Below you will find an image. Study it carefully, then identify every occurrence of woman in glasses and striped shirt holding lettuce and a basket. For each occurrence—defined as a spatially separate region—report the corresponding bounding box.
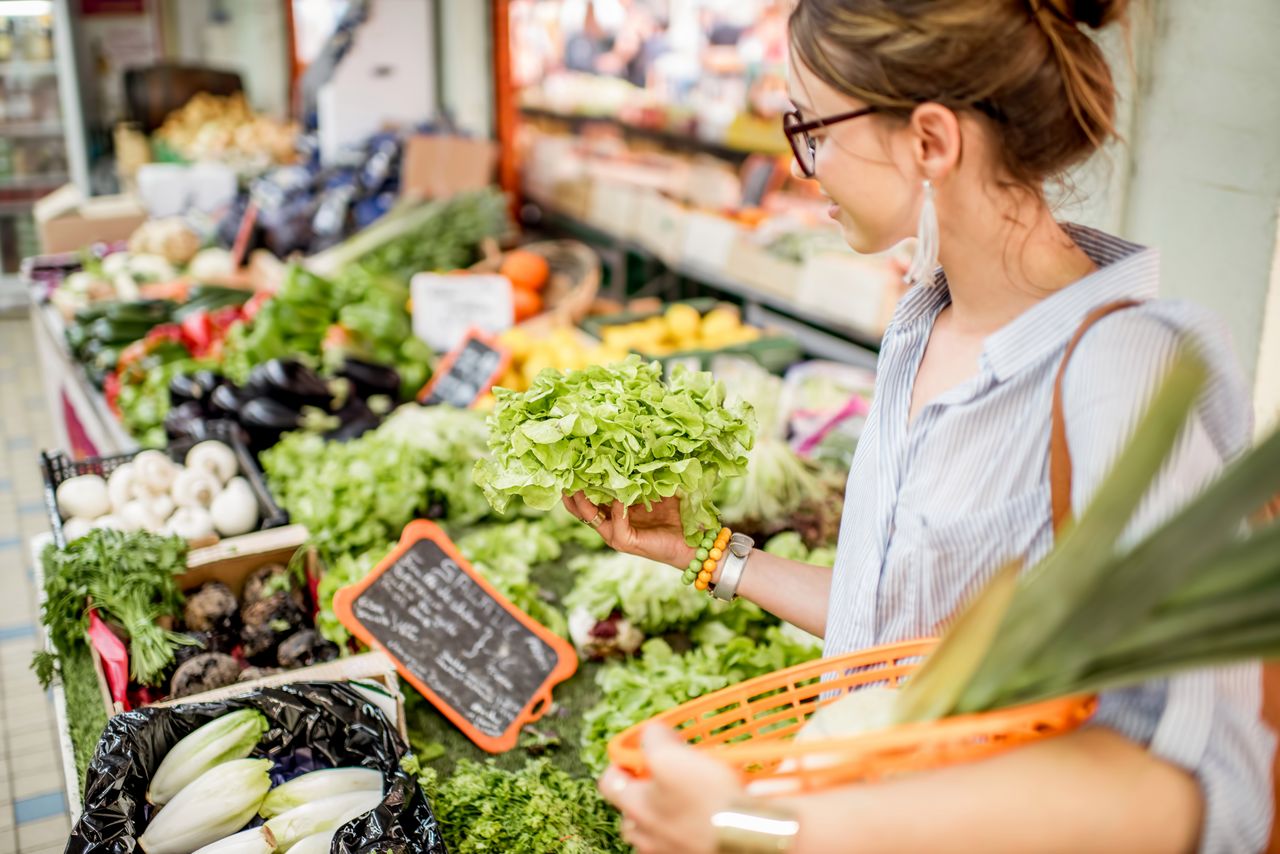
[566,0,1274,854]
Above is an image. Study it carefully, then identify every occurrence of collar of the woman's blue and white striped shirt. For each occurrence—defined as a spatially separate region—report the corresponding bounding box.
[884,223,1160,382]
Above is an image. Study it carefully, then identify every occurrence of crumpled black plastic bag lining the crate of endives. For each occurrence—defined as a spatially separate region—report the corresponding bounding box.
[67,682,447,854]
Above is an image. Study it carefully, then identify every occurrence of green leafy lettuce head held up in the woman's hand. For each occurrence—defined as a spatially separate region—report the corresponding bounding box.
[476,357,754,536]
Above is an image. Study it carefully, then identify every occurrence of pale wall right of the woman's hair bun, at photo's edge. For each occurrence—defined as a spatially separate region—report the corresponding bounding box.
[1121,0,1280,393]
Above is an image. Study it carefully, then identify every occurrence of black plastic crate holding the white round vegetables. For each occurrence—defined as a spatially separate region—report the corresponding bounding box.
[40,421,289,548]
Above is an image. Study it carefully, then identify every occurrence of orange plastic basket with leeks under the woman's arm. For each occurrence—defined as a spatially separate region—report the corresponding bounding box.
[609,640,1097,795]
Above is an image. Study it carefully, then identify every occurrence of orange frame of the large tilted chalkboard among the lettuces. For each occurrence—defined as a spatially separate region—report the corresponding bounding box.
[333,520,577,753]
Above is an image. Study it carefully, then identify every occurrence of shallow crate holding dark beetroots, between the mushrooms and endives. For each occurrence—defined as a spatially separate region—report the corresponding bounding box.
[90,525,404,736]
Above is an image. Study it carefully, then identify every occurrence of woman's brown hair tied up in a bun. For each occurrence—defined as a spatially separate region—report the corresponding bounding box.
[791,0,1128,187]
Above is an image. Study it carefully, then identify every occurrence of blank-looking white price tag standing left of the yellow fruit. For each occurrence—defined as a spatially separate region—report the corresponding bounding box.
[410,273,515,352]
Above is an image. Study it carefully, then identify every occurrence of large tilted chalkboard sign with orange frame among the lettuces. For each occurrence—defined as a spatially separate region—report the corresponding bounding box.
[333,521,577,753]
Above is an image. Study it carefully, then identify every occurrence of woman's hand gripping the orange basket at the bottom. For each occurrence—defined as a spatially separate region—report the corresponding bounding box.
[600,726,742,854]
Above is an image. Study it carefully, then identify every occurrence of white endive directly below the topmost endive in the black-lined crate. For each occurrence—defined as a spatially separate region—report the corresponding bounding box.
[138,759,274,854]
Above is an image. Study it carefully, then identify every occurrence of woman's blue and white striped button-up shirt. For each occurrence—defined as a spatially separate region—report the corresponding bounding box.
[826,225,1275,851]
